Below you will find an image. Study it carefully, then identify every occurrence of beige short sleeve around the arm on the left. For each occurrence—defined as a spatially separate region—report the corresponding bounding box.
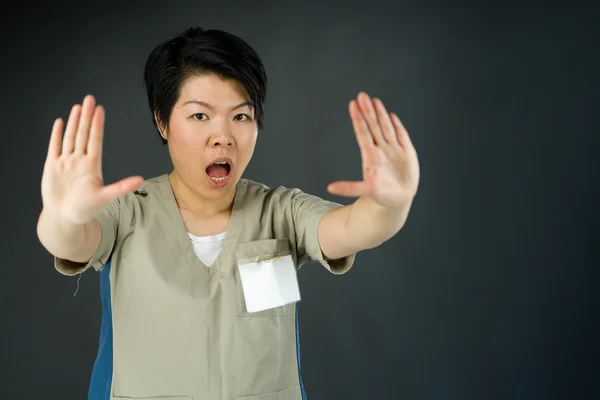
[54,199,120,276]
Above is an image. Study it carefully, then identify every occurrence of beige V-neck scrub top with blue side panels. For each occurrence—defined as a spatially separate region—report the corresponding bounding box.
[54,174,355,400]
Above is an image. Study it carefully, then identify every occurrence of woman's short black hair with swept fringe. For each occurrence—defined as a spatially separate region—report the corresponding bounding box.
[144,27,267,144]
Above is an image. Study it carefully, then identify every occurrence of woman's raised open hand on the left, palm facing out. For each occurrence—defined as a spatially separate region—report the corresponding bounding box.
[42,95,144,225]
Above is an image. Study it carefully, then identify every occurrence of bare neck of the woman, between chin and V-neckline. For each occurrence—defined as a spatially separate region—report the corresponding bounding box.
[169,170,235,218]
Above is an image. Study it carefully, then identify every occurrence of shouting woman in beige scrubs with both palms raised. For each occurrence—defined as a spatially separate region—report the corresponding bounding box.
[37,28,419,400]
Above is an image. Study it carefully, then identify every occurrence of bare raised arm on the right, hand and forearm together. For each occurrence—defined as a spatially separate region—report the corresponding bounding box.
[318,93,419,259]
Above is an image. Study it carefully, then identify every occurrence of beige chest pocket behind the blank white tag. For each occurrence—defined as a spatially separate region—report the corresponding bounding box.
[235,239,297,318]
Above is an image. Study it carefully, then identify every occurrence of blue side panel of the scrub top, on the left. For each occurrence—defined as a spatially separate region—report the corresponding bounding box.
[88,260,113,400]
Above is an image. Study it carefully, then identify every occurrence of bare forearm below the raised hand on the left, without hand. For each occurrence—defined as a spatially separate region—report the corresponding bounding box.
[37,210,102,262]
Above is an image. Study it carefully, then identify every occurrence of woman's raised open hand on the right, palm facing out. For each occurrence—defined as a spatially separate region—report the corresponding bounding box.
[327,93,420,208]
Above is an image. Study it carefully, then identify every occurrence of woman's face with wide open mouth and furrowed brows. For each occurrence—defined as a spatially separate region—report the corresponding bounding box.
[162,74,258,200]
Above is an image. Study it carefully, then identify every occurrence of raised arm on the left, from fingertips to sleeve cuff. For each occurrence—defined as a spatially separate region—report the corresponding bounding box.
[37,96,143,275]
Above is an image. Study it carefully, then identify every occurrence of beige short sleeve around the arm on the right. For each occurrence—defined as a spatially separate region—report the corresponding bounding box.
[291,189,356,275]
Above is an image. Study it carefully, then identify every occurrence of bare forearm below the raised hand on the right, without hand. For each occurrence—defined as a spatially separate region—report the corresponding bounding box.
[319,197,412,259]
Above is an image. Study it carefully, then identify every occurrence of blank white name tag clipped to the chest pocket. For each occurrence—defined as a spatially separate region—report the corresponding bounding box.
[238,255,300,313]
